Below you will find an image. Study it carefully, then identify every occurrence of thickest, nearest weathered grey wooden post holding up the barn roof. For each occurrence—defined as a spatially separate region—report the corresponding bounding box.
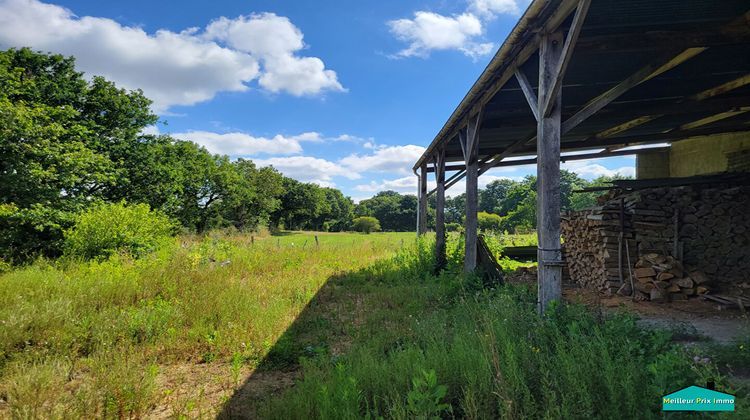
[537,32,563,313]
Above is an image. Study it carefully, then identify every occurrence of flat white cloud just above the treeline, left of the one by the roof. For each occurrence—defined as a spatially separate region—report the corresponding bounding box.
[253,156,361,186]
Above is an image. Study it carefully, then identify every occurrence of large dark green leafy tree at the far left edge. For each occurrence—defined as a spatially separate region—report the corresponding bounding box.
[0,49,156,260]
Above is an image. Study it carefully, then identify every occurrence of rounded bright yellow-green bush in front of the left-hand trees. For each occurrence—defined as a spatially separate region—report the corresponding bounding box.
[65,202,176,259]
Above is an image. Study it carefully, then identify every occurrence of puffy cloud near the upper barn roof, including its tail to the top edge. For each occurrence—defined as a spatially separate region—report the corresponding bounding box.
[387,0,529,59]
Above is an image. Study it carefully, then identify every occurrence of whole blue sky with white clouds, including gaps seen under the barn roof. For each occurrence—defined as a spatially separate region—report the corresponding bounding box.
[0,0,634,200]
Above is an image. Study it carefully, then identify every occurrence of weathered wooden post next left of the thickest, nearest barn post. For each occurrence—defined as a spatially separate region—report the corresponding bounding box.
[459,112,482,273]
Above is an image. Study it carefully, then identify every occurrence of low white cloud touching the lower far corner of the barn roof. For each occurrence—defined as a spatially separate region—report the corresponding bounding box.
[340,144,425,174]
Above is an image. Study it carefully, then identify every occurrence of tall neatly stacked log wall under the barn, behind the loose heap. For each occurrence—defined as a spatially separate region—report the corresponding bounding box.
[561,185,750,300]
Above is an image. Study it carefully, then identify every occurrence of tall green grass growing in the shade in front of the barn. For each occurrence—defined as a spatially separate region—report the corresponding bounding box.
[259,236,748,419]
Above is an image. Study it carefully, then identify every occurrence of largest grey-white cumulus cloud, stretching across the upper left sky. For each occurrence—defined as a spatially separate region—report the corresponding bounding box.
[0,0,345,113]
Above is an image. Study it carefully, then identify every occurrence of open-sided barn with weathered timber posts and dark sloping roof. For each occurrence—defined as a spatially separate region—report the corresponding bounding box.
[414,0,750,310]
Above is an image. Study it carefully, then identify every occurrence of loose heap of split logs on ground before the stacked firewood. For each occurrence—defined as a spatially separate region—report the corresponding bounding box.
[619,253,711,302]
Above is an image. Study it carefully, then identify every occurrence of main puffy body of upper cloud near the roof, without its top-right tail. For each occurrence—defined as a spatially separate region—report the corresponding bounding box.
[388,11,493,57]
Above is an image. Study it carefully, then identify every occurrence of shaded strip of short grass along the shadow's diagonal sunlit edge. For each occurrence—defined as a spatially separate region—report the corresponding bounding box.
[217,269,376,419]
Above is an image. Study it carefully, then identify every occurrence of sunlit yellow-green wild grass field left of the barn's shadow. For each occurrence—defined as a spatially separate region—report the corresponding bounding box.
[0,233,414,418]
